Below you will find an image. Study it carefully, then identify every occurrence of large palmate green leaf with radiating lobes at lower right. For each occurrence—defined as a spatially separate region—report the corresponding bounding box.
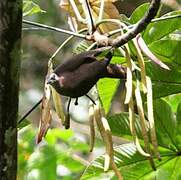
[81,99,181,180]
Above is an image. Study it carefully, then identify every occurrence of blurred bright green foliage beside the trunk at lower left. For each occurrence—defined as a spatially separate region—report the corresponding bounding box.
[18,126,89,180]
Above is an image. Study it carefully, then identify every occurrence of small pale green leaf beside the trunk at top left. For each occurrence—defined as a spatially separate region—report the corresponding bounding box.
[23,0,45,16]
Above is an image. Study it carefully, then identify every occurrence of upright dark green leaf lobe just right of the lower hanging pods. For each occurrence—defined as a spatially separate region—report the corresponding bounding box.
[154,99,178,150]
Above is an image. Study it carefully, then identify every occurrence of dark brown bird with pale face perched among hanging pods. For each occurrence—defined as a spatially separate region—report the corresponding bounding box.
[47,50,126,129]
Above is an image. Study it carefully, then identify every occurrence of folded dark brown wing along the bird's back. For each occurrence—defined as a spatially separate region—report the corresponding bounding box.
[54,51,98,75]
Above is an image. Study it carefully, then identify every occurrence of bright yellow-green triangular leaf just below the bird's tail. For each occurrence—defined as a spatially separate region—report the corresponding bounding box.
[97,78,120,113]
